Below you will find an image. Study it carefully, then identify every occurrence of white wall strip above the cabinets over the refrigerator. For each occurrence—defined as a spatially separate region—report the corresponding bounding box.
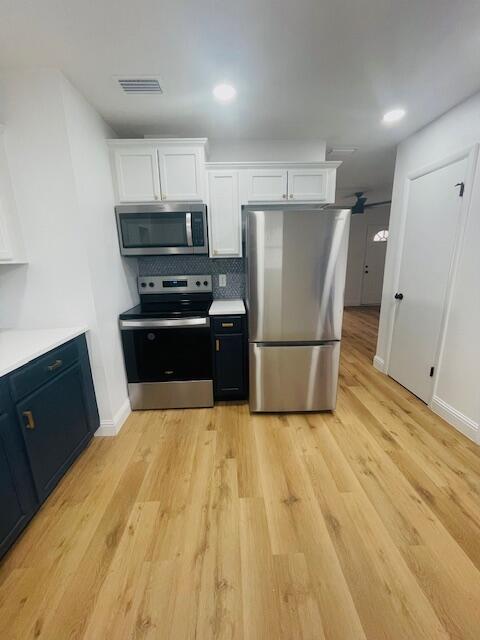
[208,139,326,162]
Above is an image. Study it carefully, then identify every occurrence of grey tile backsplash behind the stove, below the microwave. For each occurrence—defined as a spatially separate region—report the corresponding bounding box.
[138,256,245,299]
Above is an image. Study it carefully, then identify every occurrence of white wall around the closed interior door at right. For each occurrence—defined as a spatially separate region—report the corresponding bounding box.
[376,93,480,442]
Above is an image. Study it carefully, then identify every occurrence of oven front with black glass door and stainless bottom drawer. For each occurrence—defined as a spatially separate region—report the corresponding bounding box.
[120,317,213,409]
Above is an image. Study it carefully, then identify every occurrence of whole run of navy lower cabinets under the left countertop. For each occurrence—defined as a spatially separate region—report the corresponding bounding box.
[0,335,100,557]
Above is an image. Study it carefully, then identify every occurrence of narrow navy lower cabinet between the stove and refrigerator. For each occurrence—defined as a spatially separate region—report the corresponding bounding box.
[213,316,247,400]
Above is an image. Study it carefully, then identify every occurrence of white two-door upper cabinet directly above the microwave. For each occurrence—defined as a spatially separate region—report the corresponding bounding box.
[109,138,206,203]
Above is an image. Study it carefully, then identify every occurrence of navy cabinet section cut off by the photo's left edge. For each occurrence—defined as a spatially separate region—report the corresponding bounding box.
[0,380,38,558]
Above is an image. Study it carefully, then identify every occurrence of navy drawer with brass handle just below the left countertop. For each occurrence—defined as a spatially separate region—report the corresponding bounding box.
[10,340,80,400]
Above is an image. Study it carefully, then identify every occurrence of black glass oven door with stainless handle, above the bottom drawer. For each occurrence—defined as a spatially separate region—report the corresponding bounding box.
[120,318,212,383]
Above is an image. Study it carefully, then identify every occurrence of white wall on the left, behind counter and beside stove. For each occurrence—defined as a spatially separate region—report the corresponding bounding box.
[0,70,137,431]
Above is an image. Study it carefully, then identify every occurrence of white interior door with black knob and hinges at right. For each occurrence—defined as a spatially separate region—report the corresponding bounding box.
[388,158,467,402]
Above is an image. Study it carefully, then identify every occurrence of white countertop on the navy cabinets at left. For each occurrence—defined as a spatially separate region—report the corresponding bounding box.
[0,327,87,377]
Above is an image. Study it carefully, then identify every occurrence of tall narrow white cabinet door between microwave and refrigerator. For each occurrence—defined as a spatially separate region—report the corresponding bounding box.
[208,170,242,258]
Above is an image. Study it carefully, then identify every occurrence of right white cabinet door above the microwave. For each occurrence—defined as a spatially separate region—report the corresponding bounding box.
[158,145,204,201]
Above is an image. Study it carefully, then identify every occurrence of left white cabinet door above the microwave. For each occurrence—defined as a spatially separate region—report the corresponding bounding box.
[113,145,161,202]
